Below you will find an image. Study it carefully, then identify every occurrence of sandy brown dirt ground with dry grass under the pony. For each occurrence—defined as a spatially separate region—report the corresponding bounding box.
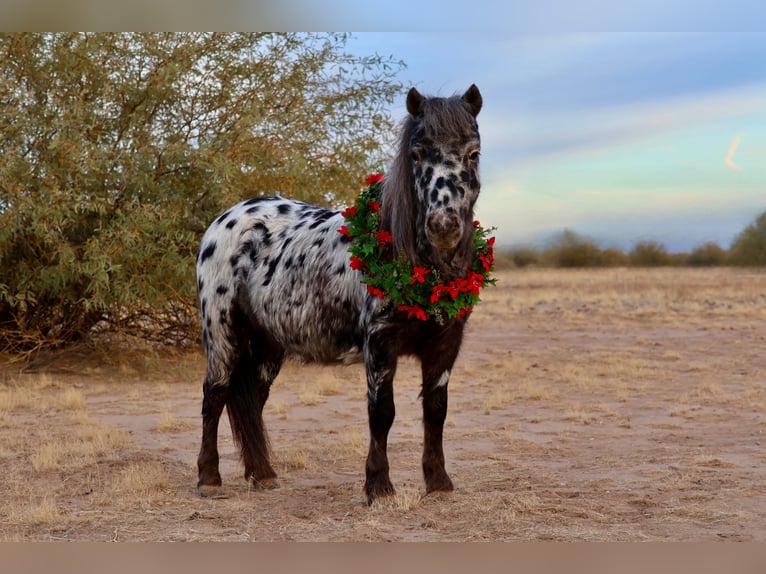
[0,269,766,541]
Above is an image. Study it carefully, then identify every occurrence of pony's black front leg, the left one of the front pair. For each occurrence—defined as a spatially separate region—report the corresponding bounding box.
[364,330,397,504]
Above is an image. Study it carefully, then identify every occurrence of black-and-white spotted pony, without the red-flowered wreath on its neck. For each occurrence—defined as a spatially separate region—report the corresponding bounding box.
[197,85,482,503]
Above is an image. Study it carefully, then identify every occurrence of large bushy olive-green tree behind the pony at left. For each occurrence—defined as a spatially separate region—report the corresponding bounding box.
[0,33,403,352]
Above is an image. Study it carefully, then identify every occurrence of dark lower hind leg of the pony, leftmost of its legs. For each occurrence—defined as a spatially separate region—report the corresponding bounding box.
[197,374,229,497]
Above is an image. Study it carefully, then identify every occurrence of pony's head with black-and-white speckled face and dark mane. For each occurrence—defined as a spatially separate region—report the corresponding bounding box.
[382,85,482,274]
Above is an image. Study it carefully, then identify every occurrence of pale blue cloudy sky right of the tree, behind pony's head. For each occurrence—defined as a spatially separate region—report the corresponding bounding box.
[347,29,766,251]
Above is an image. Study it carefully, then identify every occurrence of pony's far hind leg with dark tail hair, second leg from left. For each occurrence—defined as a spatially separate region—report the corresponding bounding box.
[226,353,276,482]
